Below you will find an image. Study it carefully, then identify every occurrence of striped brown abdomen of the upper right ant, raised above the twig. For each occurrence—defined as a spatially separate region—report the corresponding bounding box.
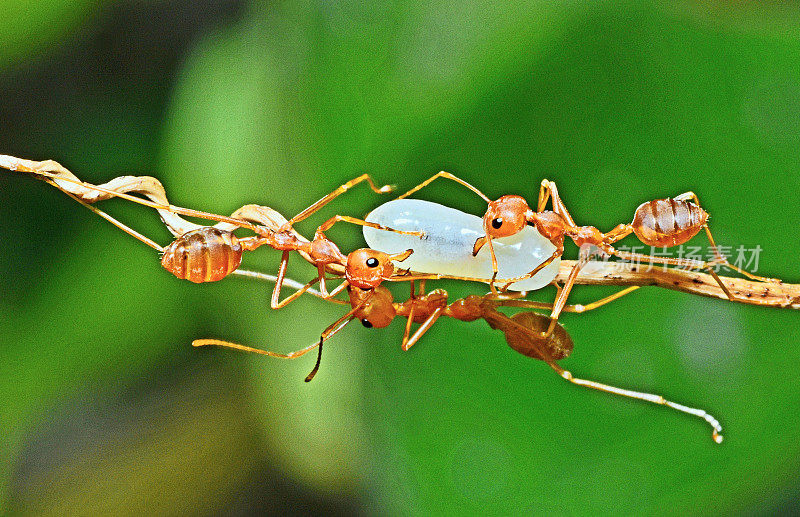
[631,198,708,247]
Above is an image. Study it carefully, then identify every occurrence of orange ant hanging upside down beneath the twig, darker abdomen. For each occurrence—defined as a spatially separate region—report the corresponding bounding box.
[192,277,722,443]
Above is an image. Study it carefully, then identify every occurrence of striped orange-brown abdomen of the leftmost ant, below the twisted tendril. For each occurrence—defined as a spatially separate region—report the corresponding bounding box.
[161,226,242,284]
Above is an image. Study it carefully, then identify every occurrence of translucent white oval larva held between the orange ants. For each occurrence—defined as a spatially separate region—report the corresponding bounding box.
[364,199,561,291]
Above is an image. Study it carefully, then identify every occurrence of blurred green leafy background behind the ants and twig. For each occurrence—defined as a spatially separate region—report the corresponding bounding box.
[0,0,800,515]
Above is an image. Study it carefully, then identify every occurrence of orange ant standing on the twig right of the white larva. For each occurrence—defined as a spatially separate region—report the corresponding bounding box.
[398,171,778,334]
